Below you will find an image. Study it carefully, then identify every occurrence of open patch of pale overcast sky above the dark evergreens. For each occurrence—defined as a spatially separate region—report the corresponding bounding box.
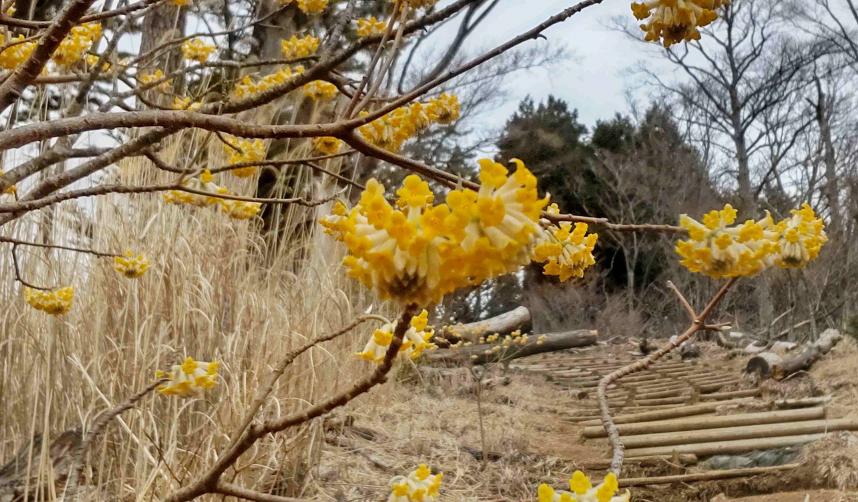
[438,0,671,134]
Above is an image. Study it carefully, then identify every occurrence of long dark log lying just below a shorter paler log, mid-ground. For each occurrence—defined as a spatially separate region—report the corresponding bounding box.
[424,329,598,365]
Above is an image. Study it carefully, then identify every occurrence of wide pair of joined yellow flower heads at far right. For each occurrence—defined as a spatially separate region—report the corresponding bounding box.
[676,203,828,278]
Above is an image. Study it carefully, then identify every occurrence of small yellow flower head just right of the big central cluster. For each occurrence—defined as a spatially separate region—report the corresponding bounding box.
[533,222,599,282]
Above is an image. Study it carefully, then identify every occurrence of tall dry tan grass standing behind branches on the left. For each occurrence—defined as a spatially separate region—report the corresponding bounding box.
[0,131,378,500]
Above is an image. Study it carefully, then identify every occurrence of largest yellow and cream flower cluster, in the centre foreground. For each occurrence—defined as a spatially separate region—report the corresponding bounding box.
[321,159,548,305]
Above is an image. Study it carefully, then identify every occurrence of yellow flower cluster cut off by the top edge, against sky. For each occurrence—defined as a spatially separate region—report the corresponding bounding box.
[632,0,729,47]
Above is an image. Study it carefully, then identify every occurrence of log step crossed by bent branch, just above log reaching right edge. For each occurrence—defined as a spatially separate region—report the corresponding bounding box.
[581,408,825,438]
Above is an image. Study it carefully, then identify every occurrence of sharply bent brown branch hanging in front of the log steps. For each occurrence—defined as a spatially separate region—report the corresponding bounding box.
[597,277,737,477]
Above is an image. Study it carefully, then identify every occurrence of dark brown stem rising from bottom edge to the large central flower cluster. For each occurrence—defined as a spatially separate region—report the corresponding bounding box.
[166,305,417,502]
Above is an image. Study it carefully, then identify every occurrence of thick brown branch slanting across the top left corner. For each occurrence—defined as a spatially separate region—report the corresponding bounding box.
[0,0,94,112]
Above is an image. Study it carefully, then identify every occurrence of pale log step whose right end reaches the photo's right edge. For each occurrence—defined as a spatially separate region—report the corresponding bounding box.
[623,418,858,448]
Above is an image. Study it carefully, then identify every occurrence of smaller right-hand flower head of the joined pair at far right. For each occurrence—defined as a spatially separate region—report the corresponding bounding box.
[775,202,828,268]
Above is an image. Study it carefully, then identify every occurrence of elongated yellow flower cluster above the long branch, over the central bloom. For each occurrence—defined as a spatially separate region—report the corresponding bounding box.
[359,93,461,152]
